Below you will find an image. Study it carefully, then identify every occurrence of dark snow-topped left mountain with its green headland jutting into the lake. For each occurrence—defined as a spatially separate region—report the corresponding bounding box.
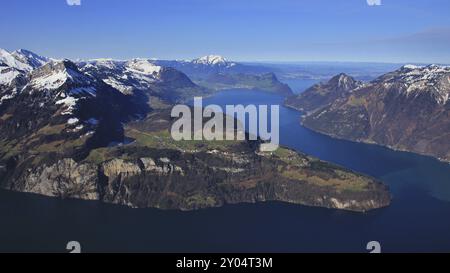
[0,48,391,211]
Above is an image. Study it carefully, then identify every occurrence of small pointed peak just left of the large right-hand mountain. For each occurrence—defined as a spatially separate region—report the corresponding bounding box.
[285,73,363,112]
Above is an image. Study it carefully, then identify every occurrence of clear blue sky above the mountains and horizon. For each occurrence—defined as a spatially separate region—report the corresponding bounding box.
[0,0,450,63]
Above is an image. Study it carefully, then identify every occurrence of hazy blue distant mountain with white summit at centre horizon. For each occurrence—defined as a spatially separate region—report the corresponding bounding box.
[153,55,292,96]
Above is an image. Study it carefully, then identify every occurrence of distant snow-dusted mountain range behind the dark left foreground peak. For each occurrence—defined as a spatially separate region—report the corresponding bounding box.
[0,49,292,103]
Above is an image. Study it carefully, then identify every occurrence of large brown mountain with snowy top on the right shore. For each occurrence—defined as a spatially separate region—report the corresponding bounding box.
[296,65,450,161]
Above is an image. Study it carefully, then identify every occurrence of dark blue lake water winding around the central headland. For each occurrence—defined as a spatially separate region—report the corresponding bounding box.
[0,91,450,252]
